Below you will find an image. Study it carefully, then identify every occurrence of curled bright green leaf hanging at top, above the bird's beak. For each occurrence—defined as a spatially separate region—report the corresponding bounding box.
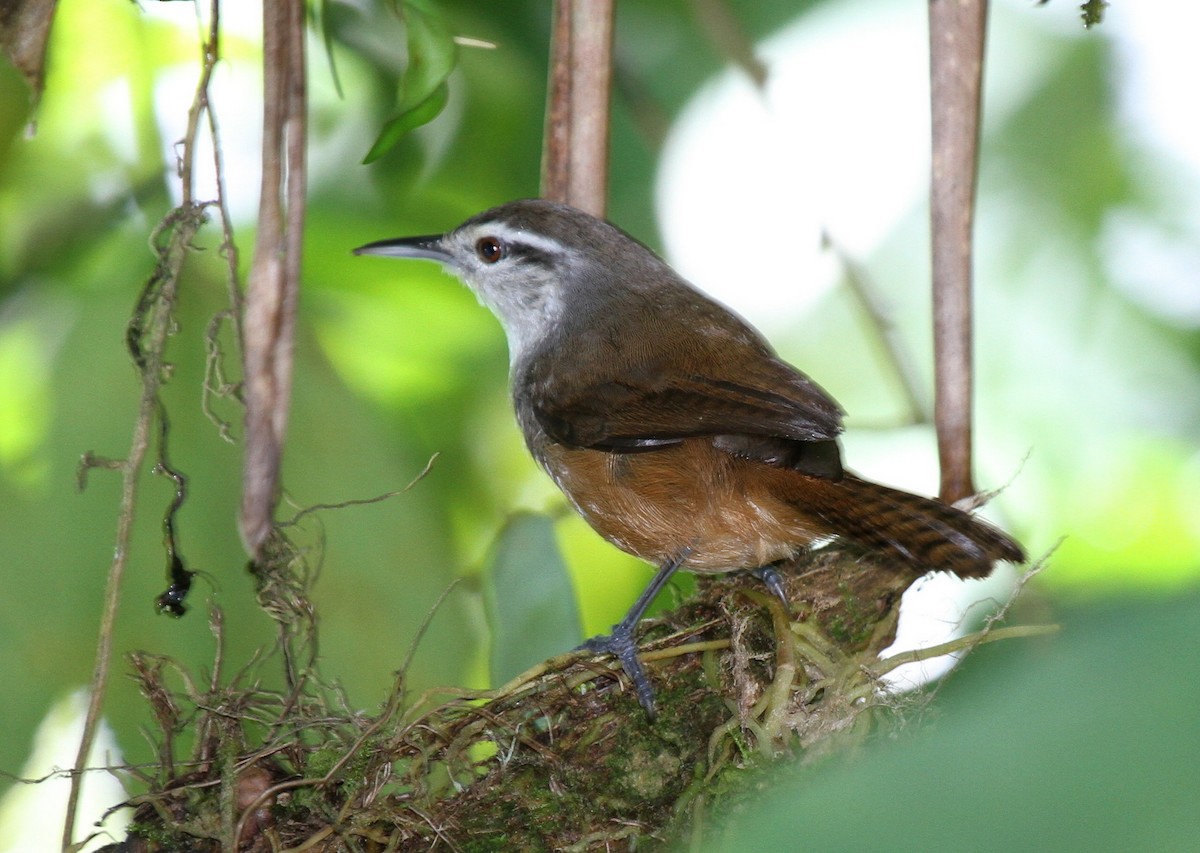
[362,0,458,163]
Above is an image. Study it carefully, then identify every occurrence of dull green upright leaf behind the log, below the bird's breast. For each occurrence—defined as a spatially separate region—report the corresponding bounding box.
[484,513,580,686]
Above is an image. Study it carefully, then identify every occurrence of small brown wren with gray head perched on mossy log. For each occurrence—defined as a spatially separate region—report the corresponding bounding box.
[354,199,1025,714]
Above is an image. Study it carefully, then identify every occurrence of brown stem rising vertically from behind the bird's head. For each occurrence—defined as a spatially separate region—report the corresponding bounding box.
[541,0,616,216]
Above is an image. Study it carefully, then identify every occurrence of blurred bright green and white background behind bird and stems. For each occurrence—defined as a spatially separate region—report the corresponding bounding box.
[0,0,1200,845]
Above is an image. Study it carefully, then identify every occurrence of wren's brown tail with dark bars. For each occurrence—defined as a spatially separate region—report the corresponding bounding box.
[804,474,1025,577]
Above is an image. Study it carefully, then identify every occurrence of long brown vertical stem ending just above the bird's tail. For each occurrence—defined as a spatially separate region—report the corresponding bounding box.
[929,0,988,503]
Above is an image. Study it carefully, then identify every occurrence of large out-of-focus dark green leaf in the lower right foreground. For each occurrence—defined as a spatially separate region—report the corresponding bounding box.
[703,593,1200,853]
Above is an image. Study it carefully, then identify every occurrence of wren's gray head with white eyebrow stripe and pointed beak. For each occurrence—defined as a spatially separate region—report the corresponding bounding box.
[354,199,673,362]
